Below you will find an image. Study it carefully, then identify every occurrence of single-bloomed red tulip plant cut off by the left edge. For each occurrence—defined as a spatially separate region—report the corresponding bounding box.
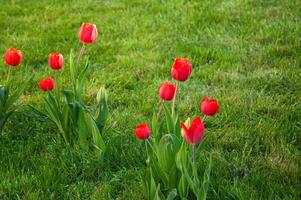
[0,48,27,132]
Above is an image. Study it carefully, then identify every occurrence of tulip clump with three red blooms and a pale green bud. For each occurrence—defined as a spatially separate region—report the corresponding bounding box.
[38,23,109,157]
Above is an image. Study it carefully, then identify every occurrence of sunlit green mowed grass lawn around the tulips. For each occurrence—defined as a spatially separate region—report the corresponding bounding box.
[0,0,301,200]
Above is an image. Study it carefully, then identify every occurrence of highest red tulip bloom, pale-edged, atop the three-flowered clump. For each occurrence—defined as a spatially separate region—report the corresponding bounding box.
[78,23,98,44]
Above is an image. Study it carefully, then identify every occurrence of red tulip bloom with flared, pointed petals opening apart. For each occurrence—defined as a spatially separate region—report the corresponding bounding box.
[180,117,205,144]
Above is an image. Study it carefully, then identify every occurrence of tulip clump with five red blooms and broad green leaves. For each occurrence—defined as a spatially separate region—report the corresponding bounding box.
[134,58,219,200]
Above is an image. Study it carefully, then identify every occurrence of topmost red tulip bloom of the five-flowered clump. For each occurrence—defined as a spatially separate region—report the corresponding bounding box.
[171,58,192,81]
